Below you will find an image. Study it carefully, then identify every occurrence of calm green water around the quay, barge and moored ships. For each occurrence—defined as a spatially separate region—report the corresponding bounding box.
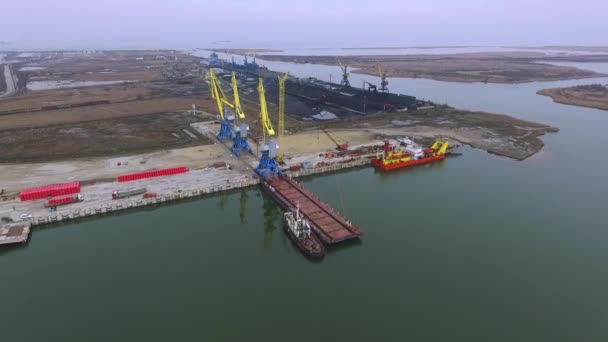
[0,58,608,341]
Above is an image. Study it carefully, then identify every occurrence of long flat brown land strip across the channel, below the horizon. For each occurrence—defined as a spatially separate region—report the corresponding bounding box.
[260,52,602,83]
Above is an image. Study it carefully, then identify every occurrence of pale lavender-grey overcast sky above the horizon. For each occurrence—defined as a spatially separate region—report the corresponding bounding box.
[0,0,608,50]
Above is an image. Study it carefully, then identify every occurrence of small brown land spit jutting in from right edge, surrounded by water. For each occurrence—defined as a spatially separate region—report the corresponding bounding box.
[537,84,608,110]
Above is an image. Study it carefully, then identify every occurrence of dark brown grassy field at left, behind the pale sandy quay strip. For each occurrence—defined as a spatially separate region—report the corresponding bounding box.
[0,112,210,163]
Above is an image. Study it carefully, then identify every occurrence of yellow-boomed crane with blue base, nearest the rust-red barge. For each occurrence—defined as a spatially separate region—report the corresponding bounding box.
[255,77,281,178]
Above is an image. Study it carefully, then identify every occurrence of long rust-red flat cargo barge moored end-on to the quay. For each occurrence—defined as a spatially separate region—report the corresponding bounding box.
[260,176,363,245]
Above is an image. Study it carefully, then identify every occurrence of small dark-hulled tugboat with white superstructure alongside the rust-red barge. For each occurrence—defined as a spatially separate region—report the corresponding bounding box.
[283,203,325,258]
